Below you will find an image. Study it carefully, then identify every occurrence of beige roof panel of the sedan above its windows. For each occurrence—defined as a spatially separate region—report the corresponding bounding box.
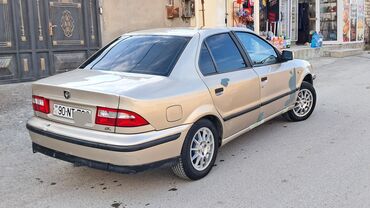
[124,27,253,37]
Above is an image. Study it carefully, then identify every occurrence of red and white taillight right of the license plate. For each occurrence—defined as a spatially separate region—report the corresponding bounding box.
[95,107,148,127]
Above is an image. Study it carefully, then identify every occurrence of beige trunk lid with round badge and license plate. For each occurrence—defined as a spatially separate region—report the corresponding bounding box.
[32,69,159,132]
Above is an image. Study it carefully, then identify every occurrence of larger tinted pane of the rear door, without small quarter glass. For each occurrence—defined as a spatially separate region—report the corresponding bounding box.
[206,33,245,73]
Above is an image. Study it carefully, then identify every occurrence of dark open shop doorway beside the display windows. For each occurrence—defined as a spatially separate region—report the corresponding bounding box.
[296,0,317,45]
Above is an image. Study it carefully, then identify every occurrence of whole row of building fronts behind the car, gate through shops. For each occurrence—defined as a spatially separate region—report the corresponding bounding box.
[0,0,370,84]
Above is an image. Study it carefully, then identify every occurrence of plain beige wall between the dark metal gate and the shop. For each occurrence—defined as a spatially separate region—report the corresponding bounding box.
[100,0,237,45]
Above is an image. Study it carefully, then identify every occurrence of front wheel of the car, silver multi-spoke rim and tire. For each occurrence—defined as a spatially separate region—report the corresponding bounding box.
[283,81,316,122]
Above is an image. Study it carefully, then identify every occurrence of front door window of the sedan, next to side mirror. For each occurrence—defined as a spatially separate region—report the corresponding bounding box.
[236,32,278,66]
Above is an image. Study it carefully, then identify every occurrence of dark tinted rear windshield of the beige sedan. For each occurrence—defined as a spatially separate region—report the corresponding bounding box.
[80,36,190,76]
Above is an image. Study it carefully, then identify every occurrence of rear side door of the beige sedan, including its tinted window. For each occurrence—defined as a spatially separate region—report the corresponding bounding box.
[199,33,260,137]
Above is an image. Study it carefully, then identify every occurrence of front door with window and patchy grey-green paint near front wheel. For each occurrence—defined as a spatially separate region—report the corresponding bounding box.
[235,32,296,119]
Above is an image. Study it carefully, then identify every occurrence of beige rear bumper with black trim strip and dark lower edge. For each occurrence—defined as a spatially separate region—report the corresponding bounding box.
[27,117,190,169]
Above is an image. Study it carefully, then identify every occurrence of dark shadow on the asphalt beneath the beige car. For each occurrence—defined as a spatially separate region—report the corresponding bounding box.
[50,117,289,185]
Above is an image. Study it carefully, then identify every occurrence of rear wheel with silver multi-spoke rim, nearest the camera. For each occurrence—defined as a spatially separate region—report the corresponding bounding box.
[172,119,220,180]
